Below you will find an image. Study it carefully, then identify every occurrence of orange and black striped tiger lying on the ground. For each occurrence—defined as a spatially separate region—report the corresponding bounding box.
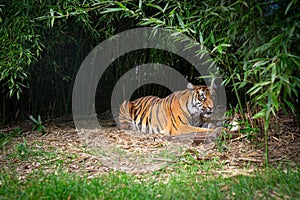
[119,83,214,136]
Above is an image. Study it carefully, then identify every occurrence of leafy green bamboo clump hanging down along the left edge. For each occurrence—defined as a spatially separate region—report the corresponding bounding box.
[0,1,44,99]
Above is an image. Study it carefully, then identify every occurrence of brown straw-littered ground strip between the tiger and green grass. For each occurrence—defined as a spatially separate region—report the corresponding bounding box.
[0,115,300,179]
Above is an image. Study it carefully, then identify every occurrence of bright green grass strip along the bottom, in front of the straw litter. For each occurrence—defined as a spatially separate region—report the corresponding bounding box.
[0,165,300,199]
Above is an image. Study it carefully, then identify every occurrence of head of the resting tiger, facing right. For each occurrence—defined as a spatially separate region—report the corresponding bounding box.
[187,83,215,118]
